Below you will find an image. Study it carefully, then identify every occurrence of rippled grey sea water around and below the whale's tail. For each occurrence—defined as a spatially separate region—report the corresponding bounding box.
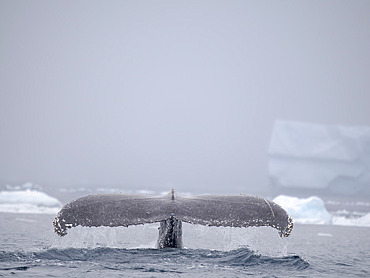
[0,213,370,277]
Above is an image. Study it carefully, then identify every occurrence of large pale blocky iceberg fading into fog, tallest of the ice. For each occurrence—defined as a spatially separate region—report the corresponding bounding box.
[268,121,370,193]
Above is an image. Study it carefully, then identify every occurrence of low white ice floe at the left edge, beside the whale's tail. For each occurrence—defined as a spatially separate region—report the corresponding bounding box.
[0,189,62,214]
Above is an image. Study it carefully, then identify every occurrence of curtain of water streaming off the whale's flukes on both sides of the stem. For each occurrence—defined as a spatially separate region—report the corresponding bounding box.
[52,222,289,257]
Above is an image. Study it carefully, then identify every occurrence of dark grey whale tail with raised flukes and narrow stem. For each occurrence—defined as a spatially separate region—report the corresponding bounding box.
[53,189,293,248]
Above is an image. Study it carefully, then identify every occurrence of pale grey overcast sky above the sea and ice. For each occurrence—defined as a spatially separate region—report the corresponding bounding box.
[0,0,370,193]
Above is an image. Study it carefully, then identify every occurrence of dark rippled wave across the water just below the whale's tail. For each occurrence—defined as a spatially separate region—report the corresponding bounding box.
[0,248,309,273]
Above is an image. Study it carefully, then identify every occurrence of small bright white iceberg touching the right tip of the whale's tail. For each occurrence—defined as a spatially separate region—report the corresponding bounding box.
[273,195,332,224]
